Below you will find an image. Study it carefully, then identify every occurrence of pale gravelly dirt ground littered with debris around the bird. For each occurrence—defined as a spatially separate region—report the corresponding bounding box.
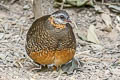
[0,0,120,80]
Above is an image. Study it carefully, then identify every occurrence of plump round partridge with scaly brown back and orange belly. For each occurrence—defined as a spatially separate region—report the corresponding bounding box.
[25,10,76,67]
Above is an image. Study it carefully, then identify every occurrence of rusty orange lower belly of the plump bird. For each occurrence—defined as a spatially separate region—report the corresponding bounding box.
[30,49,75,66]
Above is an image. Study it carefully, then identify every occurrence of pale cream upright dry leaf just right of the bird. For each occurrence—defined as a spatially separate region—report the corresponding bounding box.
[87,25,100,44]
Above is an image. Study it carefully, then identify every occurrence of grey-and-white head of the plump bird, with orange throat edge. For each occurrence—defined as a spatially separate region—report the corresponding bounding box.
[49,10,71,27]
